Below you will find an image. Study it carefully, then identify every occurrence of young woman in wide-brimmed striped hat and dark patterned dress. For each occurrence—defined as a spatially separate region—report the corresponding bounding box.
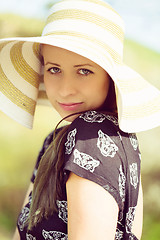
[0,0,160,240]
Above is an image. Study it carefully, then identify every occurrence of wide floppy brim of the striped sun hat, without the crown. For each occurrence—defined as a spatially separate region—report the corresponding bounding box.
[0,35,160,132]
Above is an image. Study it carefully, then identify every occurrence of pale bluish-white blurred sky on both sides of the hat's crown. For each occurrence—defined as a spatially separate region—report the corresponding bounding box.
[0,0,160,52]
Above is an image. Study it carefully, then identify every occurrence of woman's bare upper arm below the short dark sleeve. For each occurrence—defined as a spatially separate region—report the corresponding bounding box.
[66,173,118,240]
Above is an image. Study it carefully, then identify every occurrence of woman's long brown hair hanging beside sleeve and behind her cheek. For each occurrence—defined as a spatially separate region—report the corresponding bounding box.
[27,80,117,230]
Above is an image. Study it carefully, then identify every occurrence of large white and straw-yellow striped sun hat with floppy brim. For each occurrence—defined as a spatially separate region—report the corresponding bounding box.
[0,0,160,132]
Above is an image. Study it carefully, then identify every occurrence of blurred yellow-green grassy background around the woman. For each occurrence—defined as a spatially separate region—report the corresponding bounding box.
[0,14,160,240]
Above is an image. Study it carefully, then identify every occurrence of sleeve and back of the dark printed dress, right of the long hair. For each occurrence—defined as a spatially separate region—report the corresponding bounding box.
[65,111,140,240]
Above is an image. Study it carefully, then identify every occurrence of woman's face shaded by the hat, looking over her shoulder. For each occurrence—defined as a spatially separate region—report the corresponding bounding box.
[42,45,110,121]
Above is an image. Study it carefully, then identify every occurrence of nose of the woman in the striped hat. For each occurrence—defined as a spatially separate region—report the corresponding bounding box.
[59,76,77,98]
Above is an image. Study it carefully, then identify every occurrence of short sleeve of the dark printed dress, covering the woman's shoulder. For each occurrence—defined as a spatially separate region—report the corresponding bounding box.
[64,111,126,213]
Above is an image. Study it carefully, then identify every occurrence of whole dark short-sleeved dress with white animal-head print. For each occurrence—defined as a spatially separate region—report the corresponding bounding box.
[17,111,141,240]
